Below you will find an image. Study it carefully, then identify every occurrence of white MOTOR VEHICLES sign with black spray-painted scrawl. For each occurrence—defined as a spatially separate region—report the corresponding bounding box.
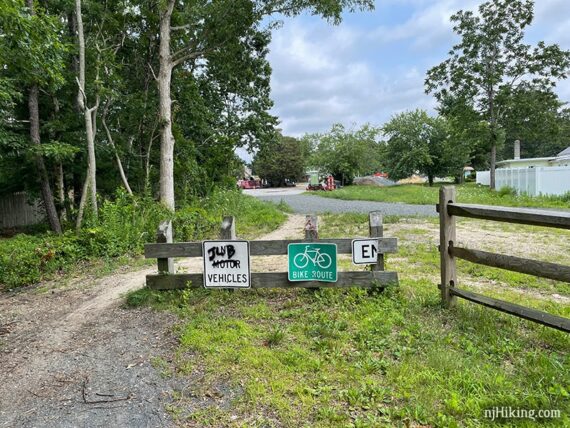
[202,241,251,288]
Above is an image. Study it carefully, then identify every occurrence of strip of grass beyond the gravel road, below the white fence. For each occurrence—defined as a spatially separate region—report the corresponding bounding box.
[316,183,570,209]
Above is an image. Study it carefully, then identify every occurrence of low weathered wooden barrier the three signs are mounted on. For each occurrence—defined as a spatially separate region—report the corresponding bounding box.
[145,212,398,290]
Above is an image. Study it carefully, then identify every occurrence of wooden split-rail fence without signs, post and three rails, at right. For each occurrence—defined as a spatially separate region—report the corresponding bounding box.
[437,187,570,332]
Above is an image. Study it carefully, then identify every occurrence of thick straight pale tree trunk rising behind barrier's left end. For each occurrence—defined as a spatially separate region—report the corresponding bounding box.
[157,0,175,211]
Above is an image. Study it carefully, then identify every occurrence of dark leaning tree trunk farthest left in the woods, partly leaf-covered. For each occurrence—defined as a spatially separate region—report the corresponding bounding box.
[26,0,61,235]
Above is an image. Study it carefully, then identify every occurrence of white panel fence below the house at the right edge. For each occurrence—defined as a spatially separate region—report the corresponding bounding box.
[476,166,570,196]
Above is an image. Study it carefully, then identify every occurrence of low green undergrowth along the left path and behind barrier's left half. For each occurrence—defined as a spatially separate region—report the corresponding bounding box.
[0,191,285,288]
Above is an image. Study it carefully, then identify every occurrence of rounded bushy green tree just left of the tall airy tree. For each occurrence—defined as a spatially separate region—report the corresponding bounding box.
[382,110,464,186]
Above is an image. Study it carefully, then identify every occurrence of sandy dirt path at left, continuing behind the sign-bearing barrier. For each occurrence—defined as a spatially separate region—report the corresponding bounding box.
[0,215,303,428]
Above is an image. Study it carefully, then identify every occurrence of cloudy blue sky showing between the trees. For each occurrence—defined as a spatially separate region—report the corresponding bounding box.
[269,0,570,136]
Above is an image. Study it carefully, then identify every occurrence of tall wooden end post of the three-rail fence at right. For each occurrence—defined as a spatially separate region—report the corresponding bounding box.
[439,186,457,308]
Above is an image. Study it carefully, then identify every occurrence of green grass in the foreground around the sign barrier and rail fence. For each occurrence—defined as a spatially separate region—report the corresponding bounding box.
[128,214,570,427]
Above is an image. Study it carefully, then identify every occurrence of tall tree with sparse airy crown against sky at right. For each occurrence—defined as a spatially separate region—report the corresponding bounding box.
[425,0,570,189]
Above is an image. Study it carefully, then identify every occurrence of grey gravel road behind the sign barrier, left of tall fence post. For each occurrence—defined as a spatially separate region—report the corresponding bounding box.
[252,193,437,217]
